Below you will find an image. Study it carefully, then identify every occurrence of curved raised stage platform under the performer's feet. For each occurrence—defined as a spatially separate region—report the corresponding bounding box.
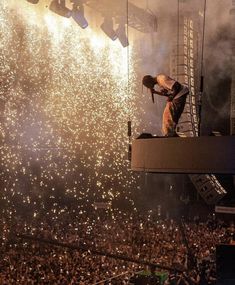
[131,136,235,174]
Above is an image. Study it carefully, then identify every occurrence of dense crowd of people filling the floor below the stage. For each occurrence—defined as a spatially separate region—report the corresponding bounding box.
[0,204,231,285]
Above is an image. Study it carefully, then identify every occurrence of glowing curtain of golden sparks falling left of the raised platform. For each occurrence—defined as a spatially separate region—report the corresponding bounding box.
[0,1,140,209]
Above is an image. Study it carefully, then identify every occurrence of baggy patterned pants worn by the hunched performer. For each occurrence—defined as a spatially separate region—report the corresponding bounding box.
[162,95,187,137]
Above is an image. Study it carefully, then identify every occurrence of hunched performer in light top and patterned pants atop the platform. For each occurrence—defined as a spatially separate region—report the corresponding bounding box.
[142,74,189,137]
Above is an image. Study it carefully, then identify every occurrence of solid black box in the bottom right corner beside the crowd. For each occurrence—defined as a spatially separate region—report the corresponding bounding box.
[216,244,235,285]
